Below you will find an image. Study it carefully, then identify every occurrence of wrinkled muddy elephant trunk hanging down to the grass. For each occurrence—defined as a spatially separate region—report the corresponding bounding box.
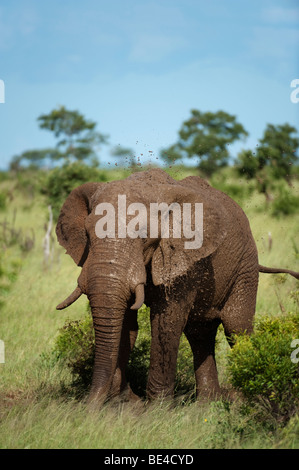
[87,241,146,403]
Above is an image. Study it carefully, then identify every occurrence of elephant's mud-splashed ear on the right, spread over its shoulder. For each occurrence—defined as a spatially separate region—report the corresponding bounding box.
[152,185,227,286]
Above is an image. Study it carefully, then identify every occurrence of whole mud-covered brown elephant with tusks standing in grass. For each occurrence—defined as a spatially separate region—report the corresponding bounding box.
[56,168,299,405]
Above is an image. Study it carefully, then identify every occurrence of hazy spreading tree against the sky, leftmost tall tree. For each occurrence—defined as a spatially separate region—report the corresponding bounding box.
[38,106,107,162]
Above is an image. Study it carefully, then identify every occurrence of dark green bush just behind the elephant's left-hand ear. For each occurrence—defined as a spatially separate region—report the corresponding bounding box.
[41,162,107,220]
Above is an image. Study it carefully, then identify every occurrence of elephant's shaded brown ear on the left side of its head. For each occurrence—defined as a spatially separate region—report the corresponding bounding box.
[56,183,103,266]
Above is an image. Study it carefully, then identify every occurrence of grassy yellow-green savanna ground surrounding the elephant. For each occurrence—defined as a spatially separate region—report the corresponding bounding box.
[0,168,299,449]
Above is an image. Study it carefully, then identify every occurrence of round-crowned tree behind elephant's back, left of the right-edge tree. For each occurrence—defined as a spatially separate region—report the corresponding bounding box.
[161,109,248,177]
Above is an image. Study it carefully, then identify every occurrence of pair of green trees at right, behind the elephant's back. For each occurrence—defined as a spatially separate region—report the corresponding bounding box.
[161,110,299,201]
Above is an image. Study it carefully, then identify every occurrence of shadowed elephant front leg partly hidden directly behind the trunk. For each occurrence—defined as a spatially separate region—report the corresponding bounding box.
[110,309,138,399]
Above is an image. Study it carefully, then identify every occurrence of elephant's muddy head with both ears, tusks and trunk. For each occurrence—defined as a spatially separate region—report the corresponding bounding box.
[56,170,225,401]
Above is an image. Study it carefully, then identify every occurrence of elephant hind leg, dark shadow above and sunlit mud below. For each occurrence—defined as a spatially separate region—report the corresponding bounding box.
[184,319,220,399]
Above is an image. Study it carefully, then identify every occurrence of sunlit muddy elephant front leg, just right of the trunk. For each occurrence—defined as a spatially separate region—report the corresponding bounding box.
[147,302,188,399]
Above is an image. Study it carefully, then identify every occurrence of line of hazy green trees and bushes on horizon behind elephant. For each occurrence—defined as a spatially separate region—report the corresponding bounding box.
[0,106,299,217]
